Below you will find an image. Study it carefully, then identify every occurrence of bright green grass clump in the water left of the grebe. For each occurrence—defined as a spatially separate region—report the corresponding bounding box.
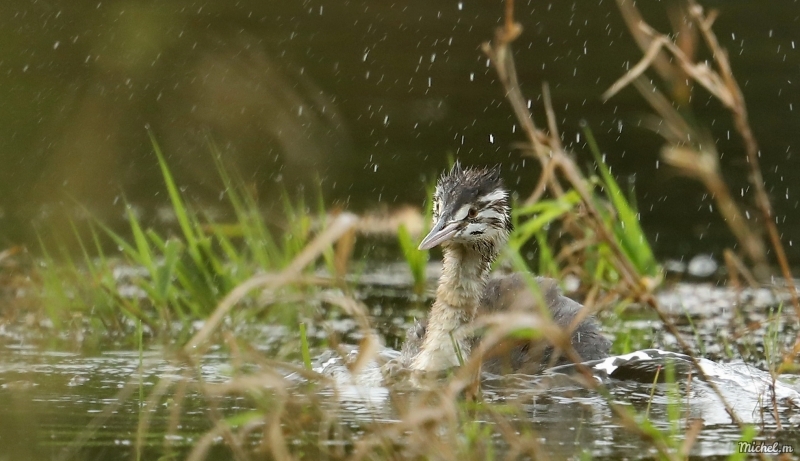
[35,134,335,342]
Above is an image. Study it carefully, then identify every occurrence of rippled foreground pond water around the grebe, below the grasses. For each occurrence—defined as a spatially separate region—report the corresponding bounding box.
[0,266,800,460]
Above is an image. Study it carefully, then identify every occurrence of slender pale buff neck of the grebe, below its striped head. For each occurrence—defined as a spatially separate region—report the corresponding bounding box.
[411,243,496,371]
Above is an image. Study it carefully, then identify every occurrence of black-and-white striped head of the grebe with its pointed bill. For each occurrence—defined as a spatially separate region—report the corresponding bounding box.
[419,162,512,255]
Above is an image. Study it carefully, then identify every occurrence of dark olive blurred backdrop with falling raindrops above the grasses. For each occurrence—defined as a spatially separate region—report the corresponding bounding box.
[0,0,800,265]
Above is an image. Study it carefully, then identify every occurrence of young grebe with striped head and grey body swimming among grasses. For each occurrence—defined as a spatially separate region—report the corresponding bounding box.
[402,162,610,373]
